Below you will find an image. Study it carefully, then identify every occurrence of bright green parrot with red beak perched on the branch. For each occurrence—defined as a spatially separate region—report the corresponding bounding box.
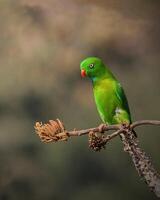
[80,57,136,136]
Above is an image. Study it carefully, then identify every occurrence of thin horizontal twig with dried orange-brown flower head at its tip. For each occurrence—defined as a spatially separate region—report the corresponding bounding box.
[35,119,160,143]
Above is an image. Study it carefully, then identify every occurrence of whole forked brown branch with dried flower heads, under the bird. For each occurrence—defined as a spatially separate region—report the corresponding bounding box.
[35,119,160,198]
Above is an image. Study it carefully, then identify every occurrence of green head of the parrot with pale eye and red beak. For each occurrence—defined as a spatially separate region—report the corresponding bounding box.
[80,57,106,80]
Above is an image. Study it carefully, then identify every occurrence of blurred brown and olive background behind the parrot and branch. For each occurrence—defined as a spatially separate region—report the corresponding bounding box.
[0,0,160,200]
